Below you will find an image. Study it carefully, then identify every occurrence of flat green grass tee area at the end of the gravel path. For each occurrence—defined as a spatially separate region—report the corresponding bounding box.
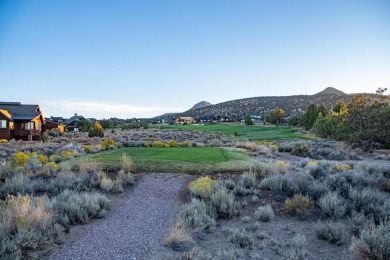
[74,147,250,174]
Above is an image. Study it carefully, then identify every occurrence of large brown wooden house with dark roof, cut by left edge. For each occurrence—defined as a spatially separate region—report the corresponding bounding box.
[0,102,45,141]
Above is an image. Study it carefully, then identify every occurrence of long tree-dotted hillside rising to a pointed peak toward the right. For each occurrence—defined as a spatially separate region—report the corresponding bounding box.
[155,87,375,118]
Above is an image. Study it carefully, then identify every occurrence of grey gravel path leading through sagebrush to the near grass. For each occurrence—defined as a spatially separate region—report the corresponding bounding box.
[48,174,191,260]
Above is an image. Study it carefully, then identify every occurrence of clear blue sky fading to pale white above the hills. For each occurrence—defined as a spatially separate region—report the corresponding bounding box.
[0,0,390,119]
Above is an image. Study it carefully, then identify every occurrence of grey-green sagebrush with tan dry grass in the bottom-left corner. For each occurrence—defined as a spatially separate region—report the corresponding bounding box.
[0,195,64,259]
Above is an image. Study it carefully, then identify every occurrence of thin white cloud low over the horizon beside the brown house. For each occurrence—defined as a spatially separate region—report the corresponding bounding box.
[42,100,186,118]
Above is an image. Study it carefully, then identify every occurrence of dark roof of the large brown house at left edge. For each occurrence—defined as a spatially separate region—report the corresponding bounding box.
[0,102,42,120]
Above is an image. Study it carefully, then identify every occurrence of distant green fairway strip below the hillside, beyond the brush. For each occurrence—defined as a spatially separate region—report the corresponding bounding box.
[153,123,307,141]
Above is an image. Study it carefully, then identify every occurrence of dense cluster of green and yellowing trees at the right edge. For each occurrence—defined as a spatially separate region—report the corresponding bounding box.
[298,88,390,151]
